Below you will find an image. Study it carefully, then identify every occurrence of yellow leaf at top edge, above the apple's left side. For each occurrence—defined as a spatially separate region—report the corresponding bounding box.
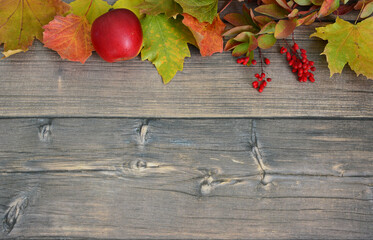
[70,0,111,24]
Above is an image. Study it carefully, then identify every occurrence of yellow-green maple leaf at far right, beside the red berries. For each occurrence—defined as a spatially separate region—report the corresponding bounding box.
[311,18,373,79]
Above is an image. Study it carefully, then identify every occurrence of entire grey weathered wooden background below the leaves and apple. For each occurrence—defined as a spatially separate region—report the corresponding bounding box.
[0,1,373,239]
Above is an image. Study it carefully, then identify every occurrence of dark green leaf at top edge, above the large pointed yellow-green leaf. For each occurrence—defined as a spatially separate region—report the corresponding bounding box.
[139,0,183,17]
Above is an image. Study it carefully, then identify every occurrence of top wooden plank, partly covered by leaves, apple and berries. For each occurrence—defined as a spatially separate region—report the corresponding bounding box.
[0,19,373,118]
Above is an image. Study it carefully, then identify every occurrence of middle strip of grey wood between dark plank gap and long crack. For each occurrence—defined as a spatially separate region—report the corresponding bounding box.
[0,118,373,177]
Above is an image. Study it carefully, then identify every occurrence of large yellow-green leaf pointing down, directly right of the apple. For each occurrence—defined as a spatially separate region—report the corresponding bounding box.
[141,14,195,84]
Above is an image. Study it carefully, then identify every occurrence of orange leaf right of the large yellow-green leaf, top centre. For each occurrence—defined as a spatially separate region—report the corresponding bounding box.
[183,13,225,57]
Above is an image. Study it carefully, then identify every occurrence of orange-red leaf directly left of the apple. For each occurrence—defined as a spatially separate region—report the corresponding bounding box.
[43,14,94,63]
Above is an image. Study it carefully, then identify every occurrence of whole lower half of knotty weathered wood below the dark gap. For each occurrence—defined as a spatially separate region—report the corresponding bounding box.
[0,118,373,239]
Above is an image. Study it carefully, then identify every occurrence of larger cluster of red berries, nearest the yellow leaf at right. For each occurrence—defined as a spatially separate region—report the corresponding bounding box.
[280,41,316,82]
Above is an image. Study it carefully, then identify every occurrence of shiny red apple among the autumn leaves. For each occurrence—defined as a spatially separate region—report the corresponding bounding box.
[91,9,143,62]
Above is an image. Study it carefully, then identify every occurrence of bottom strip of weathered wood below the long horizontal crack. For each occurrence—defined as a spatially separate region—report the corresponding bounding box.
[0,172,373,239]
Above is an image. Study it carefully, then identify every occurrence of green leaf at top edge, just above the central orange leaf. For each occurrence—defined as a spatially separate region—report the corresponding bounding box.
[175,0,218,23]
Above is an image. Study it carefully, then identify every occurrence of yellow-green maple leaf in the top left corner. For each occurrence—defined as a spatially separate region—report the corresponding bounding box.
[0,0,70,57]
